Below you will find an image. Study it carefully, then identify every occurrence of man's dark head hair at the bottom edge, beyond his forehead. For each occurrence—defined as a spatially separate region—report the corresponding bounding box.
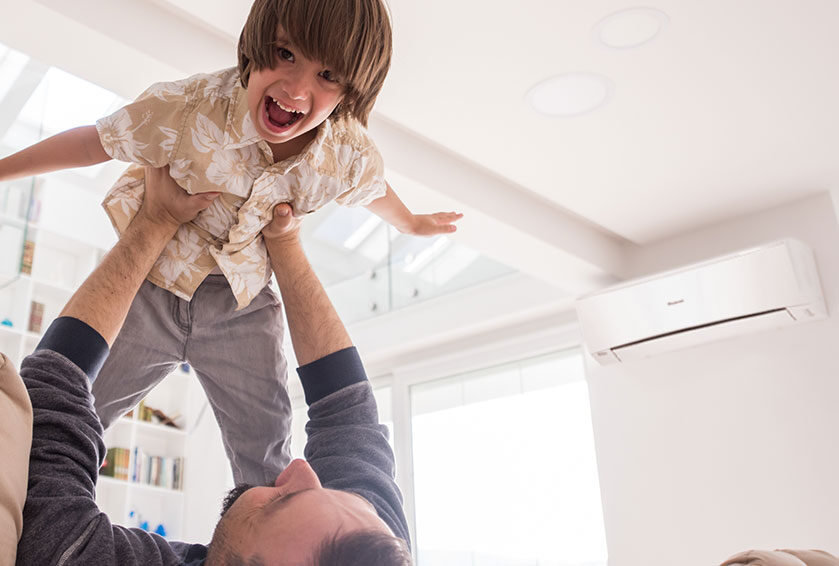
[313,530,414,566]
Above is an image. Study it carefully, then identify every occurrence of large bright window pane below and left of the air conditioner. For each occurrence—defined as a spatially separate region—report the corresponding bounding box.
[411,350,607,566]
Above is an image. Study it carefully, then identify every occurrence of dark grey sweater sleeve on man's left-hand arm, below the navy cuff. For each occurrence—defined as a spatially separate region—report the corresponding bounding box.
[17,347,190,566]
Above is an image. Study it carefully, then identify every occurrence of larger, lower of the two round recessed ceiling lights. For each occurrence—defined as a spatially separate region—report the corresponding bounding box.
[526,73,612,116]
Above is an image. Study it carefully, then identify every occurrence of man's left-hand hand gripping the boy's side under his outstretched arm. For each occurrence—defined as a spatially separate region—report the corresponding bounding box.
[140,165,221,231]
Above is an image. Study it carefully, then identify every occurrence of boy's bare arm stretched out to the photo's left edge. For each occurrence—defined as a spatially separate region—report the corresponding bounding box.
[0,126,111,181]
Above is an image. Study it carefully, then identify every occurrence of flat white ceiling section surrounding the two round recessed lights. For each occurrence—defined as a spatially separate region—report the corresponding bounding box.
[378,0,839,244]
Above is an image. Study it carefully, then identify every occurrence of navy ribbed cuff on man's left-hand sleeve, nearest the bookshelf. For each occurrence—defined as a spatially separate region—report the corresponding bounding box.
[35,316,108,381]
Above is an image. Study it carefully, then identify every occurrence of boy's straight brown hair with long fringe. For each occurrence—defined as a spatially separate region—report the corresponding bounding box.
[239,0,393,126]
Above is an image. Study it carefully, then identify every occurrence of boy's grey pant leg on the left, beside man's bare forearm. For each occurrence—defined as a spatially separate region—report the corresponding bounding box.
[92,281,189,428]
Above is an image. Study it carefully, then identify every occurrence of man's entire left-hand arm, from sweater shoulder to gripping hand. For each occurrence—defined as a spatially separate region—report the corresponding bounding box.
[17,166,218,566]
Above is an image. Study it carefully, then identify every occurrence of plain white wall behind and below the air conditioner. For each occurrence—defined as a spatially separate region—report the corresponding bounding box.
[588,194,839,566]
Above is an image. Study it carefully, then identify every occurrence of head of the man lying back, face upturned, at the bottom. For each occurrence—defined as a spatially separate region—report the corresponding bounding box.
[207,460,412,566]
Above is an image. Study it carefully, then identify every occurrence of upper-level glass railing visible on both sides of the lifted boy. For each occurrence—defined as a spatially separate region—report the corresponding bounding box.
[0,41,512,323]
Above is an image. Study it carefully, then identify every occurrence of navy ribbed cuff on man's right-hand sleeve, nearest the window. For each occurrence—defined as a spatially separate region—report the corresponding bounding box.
[297,346,367,405]
